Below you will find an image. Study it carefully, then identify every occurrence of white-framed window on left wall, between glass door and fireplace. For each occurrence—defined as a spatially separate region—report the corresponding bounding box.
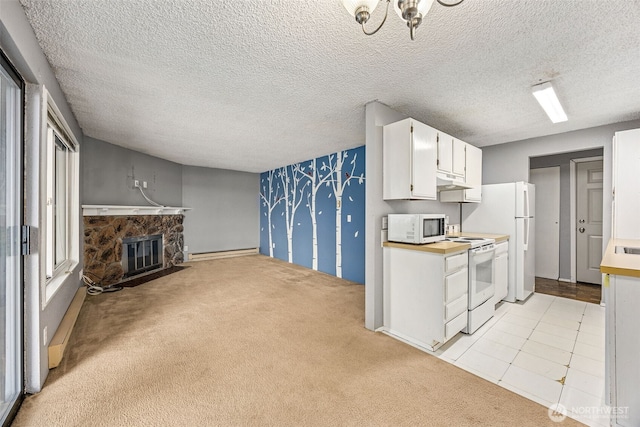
[45,105,79,303]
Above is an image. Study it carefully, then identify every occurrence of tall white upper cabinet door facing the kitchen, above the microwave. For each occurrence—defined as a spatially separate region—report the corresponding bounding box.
[411,120,438,200]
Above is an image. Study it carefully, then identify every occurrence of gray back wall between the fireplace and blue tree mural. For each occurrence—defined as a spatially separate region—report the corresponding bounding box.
[182,166,260,253]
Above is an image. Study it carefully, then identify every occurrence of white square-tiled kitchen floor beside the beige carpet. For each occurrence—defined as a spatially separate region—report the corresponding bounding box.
[433,294,609,427]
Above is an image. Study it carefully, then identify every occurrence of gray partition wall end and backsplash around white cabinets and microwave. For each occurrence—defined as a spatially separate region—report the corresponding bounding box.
[365,102,464,330]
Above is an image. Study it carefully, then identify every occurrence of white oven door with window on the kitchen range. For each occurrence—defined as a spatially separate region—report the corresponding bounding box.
[469,247,495,310]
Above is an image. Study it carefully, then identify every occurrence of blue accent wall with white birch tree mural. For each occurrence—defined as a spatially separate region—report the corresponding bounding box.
[260,146,366,283]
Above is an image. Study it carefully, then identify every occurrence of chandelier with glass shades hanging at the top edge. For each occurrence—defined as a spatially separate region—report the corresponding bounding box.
[342,0,464,40]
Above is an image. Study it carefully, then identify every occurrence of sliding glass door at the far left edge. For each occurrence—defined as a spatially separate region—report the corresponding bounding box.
[0,53,23,424]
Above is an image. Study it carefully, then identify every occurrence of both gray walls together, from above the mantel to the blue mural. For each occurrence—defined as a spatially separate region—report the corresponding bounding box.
[80,137,260,253]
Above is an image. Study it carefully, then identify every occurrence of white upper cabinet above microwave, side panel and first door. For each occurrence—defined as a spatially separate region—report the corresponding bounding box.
[382,119,438,200]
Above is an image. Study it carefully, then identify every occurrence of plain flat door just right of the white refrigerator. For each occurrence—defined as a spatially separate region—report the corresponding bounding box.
[529,166,560,280]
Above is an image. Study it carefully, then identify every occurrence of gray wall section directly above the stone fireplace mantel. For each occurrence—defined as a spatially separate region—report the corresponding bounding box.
[80,137,182,206]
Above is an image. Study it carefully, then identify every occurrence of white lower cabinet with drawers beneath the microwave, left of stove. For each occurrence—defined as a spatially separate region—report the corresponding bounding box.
[383,247,469,351]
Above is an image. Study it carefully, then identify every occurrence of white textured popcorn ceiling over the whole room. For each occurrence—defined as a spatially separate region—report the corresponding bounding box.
[21,0,640,172]
